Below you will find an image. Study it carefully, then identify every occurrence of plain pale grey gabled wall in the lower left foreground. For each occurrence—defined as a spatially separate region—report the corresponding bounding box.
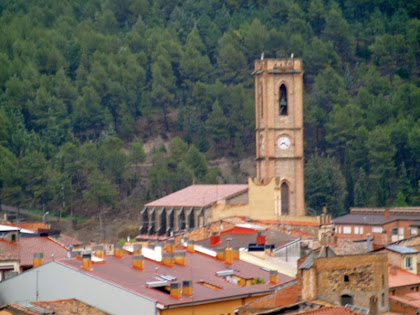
[0,262,157,315]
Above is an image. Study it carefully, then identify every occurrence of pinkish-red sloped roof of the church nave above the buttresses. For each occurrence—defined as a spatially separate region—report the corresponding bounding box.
[146,185,248,207]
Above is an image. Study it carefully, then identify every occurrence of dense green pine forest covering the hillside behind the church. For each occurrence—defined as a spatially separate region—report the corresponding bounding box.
[0,0,420,220]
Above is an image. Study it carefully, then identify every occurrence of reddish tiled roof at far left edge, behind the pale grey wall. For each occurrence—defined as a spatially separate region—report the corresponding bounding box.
[0,236,67,266]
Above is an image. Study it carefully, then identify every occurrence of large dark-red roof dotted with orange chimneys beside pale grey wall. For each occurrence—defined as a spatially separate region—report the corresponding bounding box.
[57,253,294,306]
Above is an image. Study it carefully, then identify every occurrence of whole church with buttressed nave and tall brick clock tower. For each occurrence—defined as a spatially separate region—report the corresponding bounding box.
[140,58,327,236]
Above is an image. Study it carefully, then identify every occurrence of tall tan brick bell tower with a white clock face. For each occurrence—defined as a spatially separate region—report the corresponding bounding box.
[253,58,305,216]
